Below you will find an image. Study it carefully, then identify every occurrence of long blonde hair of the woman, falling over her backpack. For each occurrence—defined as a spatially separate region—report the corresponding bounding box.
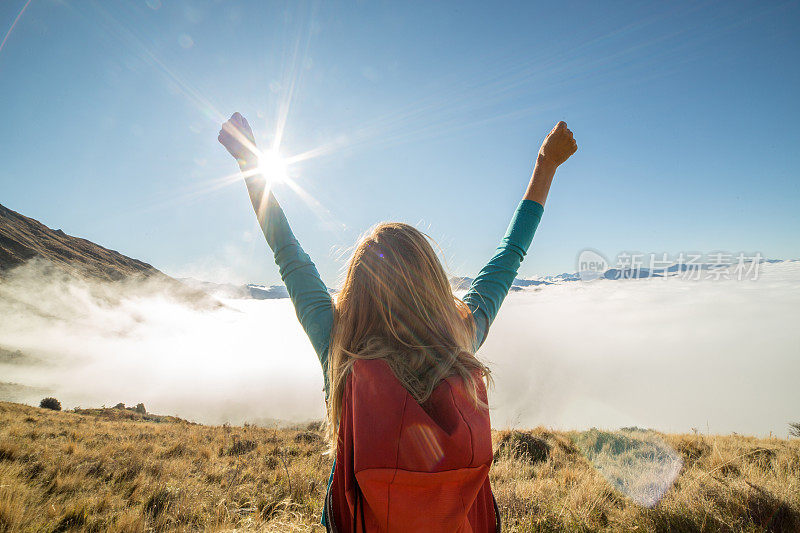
[327,222,491,449]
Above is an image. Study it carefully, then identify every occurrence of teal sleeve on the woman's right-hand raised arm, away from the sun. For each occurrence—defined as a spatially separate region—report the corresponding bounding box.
[463,200,544,350]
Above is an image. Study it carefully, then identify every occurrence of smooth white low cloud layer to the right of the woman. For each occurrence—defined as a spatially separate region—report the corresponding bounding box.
[481,262,800,437]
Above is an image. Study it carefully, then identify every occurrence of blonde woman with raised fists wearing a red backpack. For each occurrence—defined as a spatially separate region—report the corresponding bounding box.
[218,113,577,532]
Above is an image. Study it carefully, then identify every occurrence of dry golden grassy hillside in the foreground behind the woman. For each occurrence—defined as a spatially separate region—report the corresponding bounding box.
[0,403,800,531]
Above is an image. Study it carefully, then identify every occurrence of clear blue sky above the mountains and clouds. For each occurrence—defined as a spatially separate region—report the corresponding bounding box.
[0,0,800,285]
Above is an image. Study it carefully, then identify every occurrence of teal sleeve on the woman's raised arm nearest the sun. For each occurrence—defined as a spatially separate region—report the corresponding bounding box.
[261,191,333,397]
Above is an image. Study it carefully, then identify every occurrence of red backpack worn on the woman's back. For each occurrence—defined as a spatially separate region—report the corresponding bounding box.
[325,359,500,533]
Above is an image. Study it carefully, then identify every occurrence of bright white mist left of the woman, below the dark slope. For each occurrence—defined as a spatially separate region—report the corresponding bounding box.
[0,267,324,424]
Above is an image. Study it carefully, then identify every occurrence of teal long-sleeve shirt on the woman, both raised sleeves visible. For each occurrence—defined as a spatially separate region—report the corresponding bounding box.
[262,192,544,398]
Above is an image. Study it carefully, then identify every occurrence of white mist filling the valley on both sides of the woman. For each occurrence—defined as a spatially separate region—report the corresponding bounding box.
[0,262,800,436]
